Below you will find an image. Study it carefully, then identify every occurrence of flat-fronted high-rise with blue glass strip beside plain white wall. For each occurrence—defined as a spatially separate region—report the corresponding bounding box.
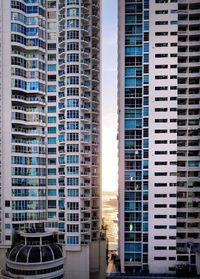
[118,0,200,274]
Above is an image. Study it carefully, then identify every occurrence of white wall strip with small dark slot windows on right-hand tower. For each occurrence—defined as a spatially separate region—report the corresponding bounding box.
[148,0,178,273]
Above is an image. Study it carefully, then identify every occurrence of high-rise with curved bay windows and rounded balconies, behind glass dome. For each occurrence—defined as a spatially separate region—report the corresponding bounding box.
[0,0,106,278]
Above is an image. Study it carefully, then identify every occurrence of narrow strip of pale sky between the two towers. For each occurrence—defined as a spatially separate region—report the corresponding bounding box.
[102,0,118,191]
